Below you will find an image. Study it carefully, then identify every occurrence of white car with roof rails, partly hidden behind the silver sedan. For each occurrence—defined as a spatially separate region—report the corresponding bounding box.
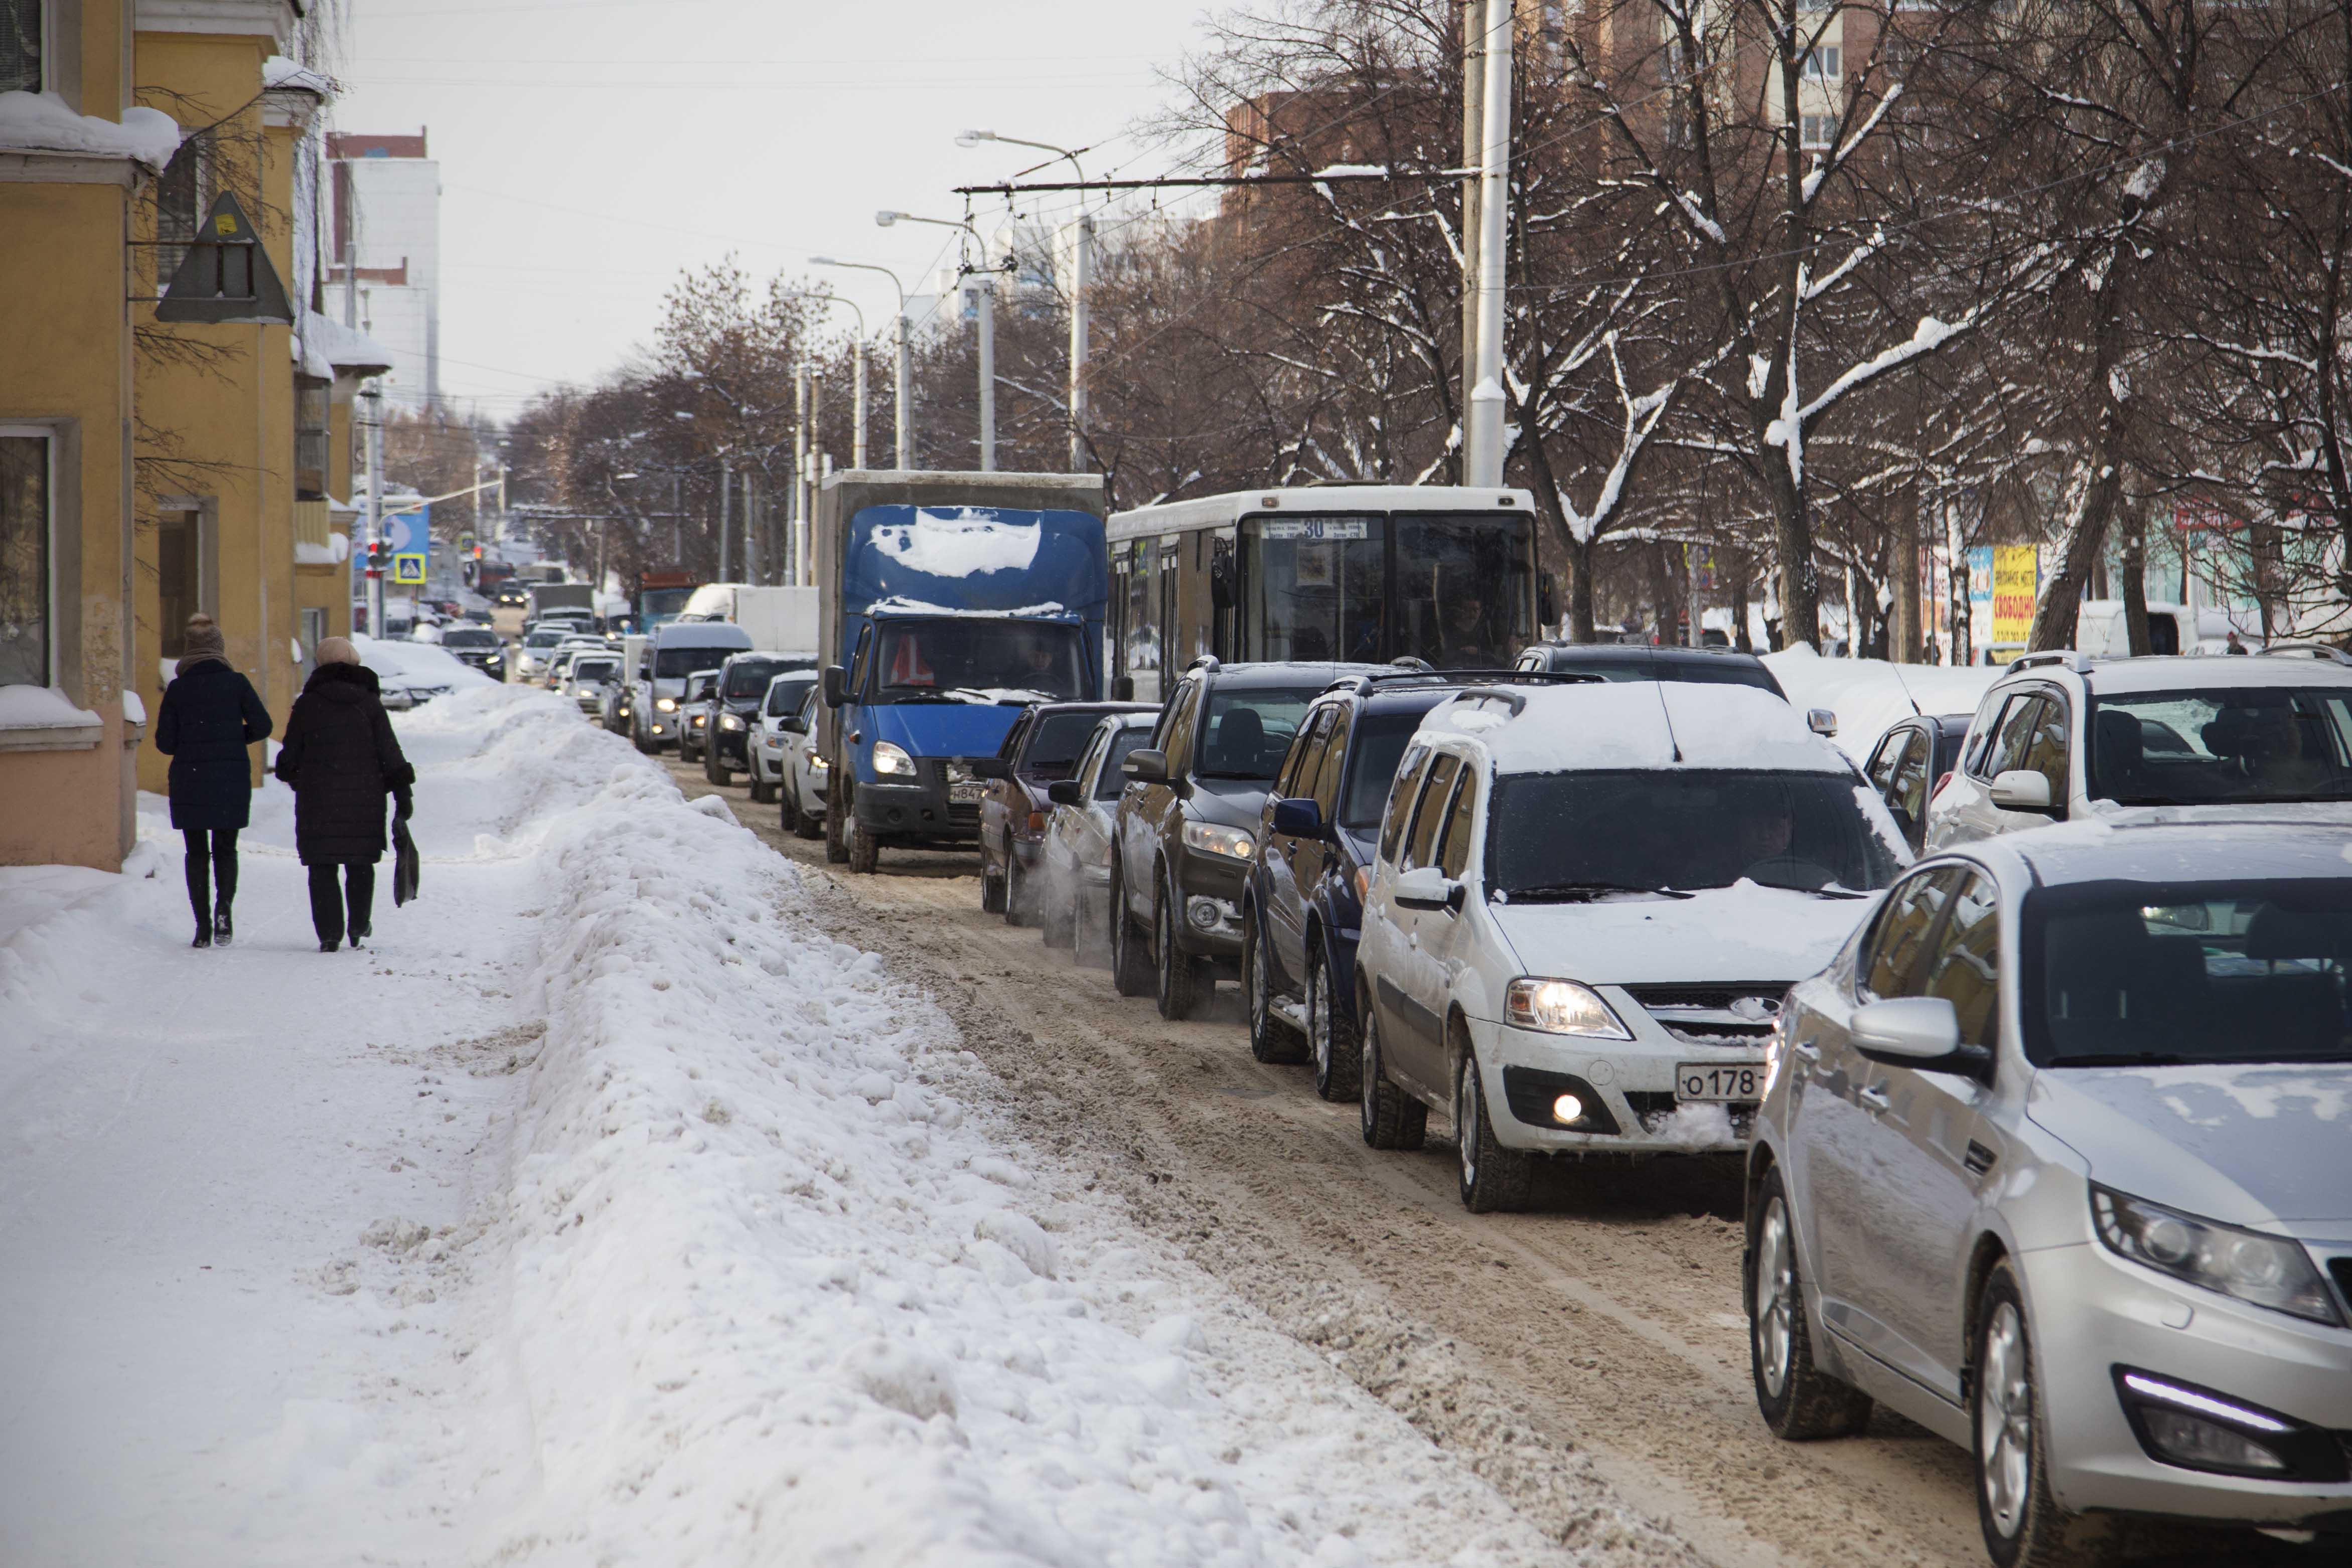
[1926,644,2352,851]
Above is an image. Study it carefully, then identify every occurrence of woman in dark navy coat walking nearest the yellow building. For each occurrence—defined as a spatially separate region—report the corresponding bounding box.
[155,616,270,948]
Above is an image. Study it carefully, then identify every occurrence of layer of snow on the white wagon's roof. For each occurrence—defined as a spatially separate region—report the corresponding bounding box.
[1421,682,1853,773]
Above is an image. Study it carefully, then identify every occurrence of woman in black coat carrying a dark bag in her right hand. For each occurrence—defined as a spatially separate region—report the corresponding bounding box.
[277,637,416,952]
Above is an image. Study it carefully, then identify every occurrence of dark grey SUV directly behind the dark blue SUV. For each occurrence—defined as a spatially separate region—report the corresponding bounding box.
[1110,658,1385,1018]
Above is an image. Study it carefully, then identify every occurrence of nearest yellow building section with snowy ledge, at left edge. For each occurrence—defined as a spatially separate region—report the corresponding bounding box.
[0,0,163,870]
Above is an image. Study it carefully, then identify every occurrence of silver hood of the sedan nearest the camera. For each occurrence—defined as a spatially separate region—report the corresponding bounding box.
[2025,1062,2352,1225]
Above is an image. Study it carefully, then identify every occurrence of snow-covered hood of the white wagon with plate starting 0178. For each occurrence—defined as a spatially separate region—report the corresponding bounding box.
[1487,881,1877,985]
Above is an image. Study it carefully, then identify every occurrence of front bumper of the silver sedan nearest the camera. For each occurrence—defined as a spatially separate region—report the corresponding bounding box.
[2023,1241,2352,1533]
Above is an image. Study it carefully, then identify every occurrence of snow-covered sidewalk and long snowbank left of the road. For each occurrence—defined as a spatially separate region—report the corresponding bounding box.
[0,689,1661,1568]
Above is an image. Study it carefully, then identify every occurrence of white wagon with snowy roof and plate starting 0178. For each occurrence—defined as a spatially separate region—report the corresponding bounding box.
[1355,682,1910,1211]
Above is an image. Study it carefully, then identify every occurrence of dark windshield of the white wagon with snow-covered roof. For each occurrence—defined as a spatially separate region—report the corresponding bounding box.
[1487,769,1900,900]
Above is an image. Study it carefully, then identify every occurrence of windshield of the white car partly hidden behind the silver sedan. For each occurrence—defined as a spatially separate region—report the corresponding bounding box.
[2089,687,2352,807]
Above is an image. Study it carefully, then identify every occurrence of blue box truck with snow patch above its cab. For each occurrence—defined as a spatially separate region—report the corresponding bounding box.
[811,470,1110,872]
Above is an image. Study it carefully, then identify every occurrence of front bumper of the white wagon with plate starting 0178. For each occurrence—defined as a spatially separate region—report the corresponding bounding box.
[1470,1018,1764,1154]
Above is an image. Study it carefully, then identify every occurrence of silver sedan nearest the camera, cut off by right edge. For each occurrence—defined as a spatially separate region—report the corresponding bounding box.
[1745,823,2352,1568]
